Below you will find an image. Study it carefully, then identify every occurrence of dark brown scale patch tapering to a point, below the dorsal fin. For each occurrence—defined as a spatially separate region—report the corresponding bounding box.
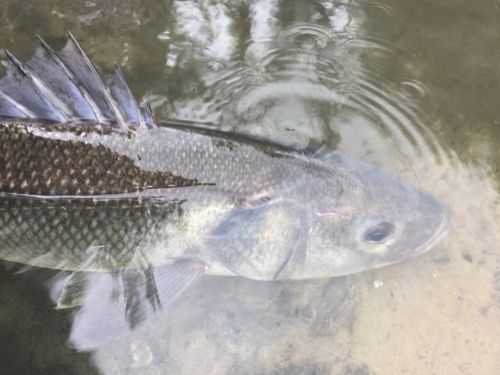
[0,124,207,195]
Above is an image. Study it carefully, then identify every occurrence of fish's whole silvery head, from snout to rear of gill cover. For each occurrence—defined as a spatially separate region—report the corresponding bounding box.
[205,154,451,280]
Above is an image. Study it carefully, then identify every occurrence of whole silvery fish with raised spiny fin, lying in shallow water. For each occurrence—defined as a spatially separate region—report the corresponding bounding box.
[0,33,451,350]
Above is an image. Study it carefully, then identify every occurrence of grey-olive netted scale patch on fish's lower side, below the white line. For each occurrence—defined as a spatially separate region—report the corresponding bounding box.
[0,197,181,272]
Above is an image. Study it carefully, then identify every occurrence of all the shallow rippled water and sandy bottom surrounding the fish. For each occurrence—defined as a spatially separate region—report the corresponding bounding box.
[0,0,500,375]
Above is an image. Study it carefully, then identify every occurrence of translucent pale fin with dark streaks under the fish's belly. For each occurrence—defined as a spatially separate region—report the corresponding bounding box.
[64,260,206,350]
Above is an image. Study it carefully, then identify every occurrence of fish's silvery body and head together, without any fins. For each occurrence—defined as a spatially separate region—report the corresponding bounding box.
[0,124,449,280]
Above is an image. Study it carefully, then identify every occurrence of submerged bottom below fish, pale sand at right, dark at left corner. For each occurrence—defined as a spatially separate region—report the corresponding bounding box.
[0,166,500,375]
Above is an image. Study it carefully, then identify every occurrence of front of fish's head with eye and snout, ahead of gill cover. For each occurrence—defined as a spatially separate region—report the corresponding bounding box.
[290,156,451,278]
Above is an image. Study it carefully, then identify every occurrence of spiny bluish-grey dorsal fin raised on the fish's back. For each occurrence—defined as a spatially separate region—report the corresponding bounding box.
[0,33,156,128]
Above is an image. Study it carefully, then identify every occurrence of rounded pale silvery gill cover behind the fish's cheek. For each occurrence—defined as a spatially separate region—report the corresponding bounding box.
[205,201,308,280]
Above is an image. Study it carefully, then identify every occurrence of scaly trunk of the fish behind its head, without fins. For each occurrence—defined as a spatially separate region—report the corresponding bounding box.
[0,124,328,273]
